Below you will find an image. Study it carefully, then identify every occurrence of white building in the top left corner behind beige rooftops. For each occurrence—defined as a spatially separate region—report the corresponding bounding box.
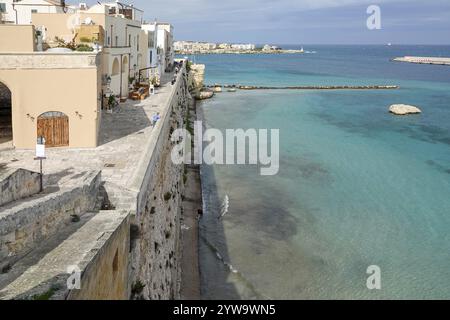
[0,0,75,24]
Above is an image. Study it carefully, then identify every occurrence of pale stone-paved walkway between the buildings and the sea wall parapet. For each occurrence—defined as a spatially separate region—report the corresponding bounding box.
[0,74,180,192]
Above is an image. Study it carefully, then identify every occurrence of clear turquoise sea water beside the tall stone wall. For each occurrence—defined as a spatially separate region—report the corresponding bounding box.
[191,46,450,299]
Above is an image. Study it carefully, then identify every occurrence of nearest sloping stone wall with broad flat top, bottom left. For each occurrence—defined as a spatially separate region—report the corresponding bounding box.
[0,211,129,300]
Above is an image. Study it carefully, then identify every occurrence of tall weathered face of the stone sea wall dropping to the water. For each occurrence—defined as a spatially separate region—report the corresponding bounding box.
[130,69,191,300]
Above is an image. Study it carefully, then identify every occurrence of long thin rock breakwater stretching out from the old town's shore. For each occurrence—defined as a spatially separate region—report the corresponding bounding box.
[205,84,400,90]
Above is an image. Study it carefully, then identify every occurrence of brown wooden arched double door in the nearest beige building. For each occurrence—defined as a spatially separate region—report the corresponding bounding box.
[37,111,69,148]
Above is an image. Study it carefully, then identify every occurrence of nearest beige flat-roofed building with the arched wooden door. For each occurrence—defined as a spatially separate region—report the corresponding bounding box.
[0,25,101,148]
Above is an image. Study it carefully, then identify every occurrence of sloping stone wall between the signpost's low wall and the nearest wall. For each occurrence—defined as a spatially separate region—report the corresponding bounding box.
[0,172,101,264]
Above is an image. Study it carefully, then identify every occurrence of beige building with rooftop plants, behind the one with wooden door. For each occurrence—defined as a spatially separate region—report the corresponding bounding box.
[32,2,148,99]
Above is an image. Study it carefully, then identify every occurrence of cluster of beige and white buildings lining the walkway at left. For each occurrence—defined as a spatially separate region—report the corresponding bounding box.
[0,0,175,148]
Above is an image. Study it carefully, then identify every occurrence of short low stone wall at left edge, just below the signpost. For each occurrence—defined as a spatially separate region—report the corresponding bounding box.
[0,169,39,206]
